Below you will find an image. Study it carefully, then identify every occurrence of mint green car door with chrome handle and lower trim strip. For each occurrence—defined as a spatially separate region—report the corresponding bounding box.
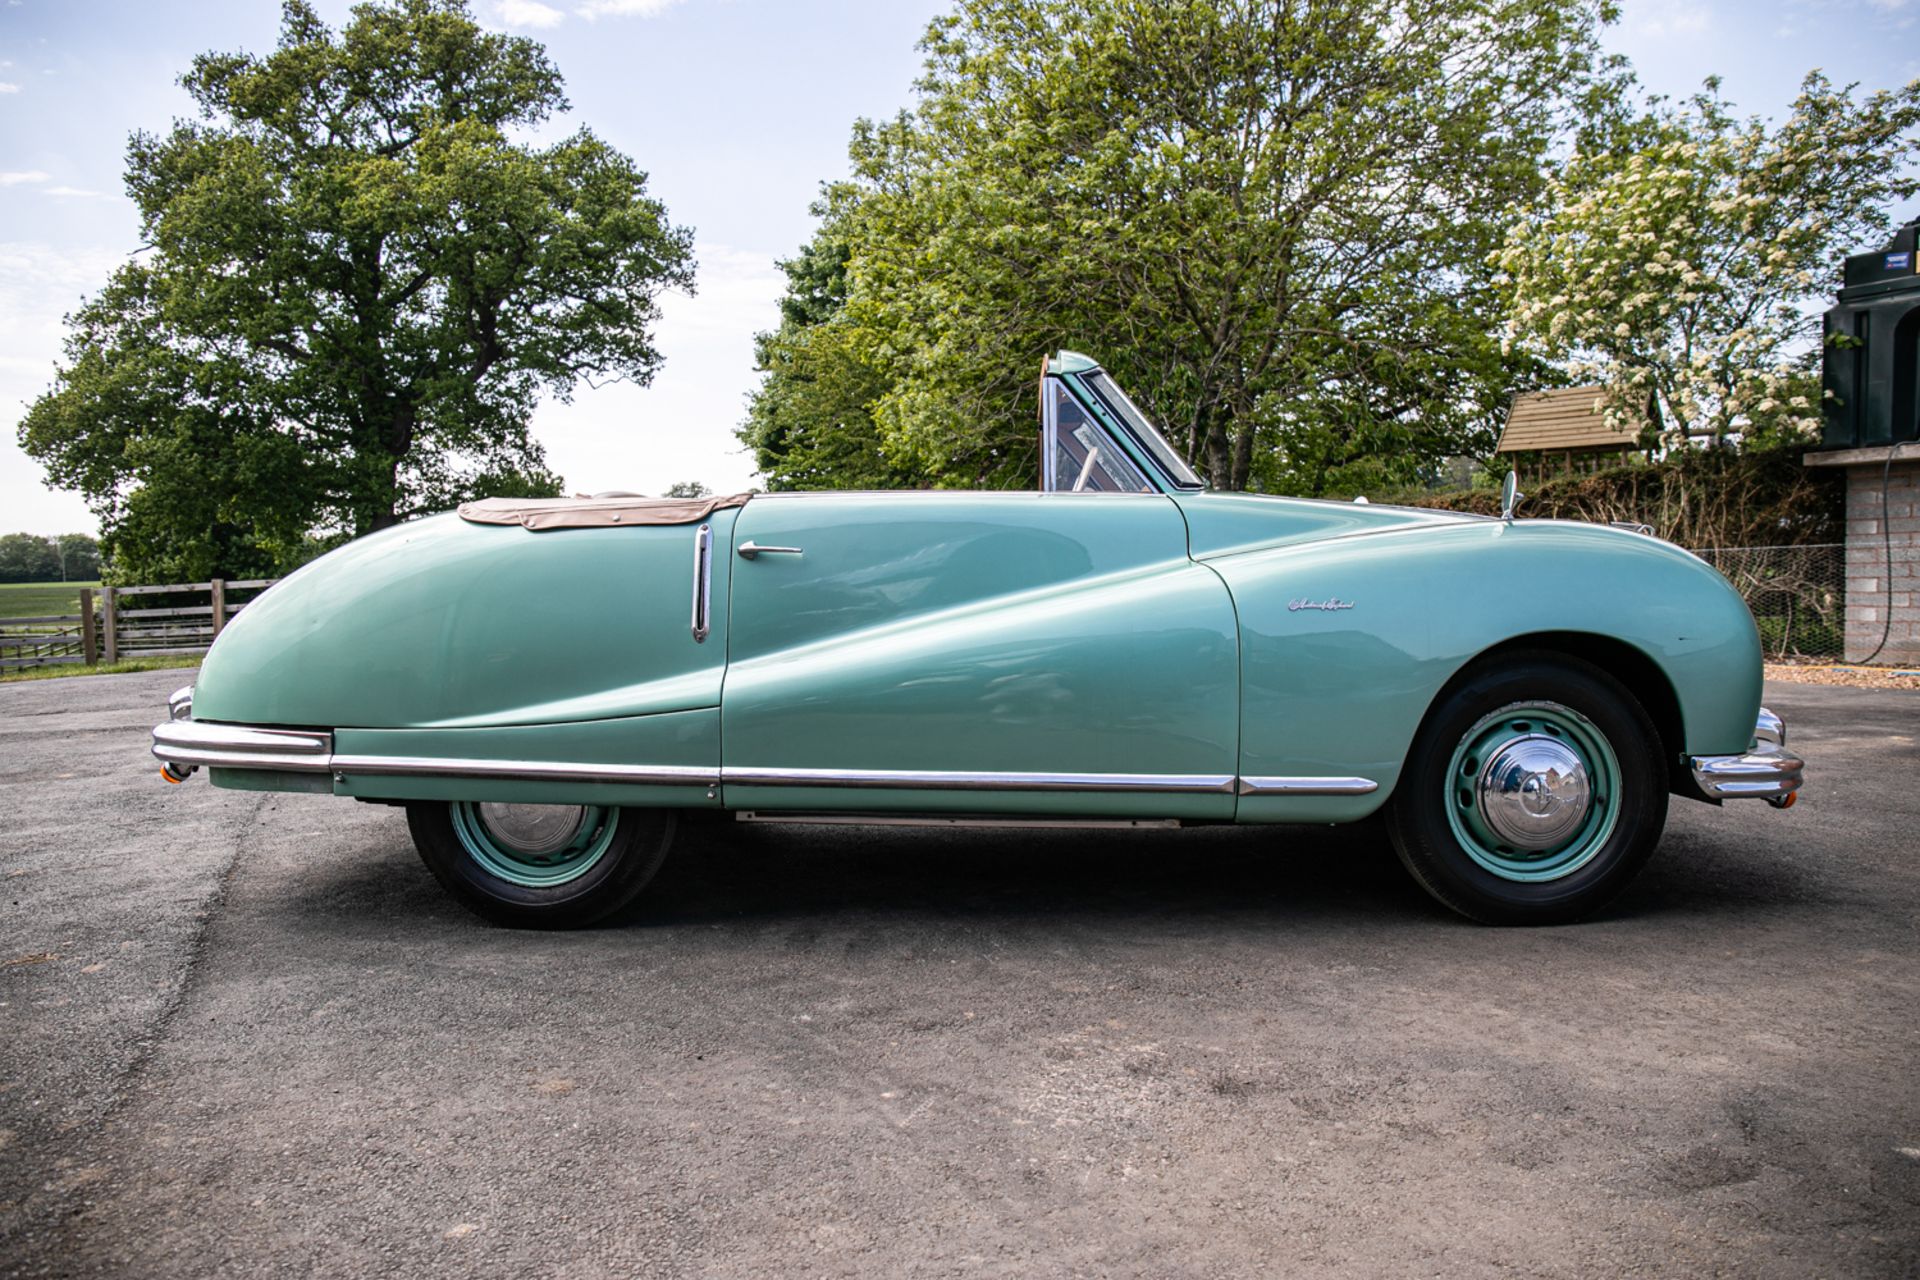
[722,493,1238,818]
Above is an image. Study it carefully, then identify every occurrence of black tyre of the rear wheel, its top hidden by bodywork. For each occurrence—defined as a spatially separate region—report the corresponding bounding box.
[407,800,676,929]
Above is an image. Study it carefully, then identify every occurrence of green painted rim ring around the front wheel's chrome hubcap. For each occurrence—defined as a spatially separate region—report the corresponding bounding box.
[1442,702,1620,883]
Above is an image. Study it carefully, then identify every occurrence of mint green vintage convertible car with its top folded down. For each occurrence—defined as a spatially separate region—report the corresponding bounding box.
[154,353,1803,927]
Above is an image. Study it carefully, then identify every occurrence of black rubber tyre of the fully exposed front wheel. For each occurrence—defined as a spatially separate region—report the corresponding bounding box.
[1386,652,1667,925]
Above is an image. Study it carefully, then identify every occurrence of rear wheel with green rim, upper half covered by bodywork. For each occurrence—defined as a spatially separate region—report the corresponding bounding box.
[407,800,674,929]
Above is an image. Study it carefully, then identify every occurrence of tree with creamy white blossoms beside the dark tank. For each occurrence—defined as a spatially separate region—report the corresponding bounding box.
[1494,73,1920,450]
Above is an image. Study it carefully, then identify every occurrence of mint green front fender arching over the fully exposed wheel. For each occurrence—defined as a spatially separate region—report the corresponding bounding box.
[1208,520,1761,821]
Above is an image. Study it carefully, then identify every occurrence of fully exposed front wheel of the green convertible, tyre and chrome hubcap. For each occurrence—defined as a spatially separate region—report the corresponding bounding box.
[1388,652,1667,925]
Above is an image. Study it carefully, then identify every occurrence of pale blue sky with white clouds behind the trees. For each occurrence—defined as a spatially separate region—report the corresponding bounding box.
[0,0,1920,533]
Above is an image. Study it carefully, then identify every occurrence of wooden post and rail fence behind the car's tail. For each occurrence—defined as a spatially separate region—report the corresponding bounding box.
[0,578,278,672]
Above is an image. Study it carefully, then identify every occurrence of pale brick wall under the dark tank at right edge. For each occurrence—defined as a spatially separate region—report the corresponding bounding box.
[1847,459,1920,664]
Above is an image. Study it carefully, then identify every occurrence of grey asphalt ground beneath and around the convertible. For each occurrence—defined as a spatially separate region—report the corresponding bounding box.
[0,672,1920,1280]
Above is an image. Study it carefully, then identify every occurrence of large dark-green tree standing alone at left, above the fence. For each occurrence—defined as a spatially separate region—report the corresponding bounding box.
[21,0,693,578]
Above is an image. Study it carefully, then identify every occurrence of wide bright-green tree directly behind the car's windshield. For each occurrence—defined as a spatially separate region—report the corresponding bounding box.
[743,0,1613,493]
